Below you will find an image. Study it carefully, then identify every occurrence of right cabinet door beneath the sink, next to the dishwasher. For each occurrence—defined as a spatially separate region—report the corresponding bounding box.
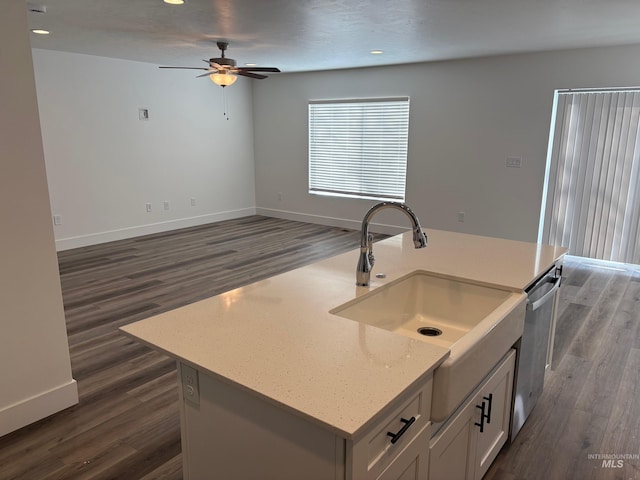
[474,350,515,480]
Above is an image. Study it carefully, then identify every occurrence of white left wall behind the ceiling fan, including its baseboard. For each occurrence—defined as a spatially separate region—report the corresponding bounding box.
[33,49,255,249]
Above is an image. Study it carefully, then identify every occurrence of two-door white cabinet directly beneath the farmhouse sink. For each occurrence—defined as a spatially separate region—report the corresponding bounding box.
[429,350,515,480]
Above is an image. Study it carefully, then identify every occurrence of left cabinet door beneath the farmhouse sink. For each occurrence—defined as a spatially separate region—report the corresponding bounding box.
[429,402,478,480]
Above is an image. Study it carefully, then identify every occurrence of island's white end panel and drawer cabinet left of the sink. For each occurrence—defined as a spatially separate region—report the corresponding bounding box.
[178,368,432,480]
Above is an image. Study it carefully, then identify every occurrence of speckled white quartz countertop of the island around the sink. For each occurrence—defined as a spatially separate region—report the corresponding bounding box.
[121,229,566,438]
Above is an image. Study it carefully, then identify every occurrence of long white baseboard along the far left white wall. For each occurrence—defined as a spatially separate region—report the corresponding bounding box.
[56,207,256,252]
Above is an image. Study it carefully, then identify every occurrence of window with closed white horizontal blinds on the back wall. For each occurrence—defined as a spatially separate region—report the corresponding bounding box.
[309,97,409,202]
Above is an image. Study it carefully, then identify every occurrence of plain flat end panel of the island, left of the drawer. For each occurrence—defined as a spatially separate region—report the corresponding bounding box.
[181,372,344,480]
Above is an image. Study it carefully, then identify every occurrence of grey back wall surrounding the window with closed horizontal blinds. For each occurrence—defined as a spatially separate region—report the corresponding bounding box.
[253,46,640,241]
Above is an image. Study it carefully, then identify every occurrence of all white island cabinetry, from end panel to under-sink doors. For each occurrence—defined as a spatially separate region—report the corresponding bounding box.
[178,344,515,480]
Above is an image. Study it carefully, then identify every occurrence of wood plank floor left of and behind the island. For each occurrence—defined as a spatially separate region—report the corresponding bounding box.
[0,216,376,480]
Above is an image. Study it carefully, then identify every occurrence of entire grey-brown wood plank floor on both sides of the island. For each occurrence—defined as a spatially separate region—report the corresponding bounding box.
[0,216,640,480]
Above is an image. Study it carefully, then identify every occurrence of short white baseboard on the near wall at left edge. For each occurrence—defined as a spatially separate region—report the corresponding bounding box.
[0,379,78,437]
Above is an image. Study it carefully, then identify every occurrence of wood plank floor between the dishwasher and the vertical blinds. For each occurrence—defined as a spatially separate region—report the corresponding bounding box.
[485,259,640,480]
